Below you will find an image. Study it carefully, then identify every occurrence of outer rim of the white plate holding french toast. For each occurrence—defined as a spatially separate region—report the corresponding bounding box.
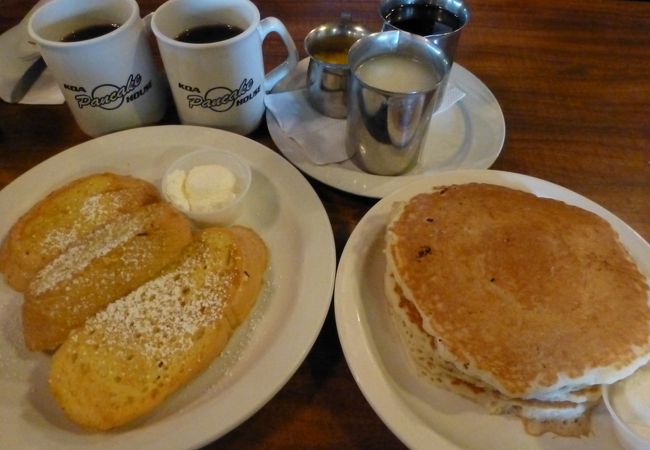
[0,125,336,449]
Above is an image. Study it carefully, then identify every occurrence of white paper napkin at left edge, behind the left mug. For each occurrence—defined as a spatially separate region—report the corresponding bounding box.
[0,0,64,105]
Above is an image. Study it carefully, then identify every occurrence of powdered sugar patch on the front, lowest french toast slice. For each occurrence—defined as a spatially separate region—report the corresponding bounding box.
[87,244,235,361]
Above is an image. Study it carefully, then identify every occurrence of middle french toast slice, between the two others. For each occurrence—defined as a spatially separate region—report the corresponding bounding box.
[22,202,192,350]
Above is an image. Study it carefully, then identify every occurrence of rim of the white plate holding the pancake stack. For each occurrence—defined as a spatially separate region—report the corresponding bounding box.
[334,169,650,449]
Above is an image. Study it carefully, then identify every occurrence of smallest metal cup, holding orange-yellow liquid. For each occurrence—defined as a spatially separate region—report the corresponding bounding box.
[305,13,369,119]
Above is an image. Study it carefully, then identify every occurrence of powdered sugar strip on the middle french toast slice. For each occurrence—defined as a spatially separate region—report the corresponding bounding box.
[31,214,143,295]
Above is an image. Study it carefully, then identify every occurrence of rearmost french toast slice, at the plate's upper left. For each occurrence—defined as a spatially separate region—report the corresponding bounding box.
[0,172,160,292]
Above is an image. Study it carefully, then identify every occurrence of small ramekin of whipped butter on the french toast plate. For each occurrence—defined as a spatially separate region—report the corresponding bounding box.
[162,148,251,225]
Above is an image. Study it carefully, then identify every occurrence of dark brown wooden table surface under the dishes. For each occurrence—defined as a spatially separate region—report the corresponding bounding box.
[0,0,650,449]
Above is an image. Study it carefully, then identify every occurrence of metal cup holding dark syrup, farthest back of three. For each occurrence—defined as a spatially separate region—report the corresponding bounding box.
[379,0,470,62]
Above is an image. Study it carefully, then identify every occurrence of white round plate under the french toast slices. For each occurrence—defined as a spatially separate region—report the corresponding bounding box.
[0,126,336,449]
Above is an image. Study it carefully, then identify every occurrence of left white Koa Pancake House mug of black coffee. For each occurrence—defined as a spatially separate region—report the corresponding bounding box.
[28,0,167,136]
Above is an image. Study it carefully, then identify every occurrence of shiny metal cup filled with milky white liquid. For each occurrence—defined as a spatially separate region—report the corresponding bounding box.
[346,31,451,175]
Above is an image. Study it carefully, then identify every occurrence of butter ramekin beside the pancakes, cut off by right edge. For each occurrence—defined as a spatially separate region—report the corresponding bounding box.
[602,366,650,450]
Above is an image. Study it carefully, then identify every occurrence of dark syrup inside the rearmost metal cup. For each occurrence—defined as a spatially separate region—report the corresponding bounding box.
[385,3,462,36]
